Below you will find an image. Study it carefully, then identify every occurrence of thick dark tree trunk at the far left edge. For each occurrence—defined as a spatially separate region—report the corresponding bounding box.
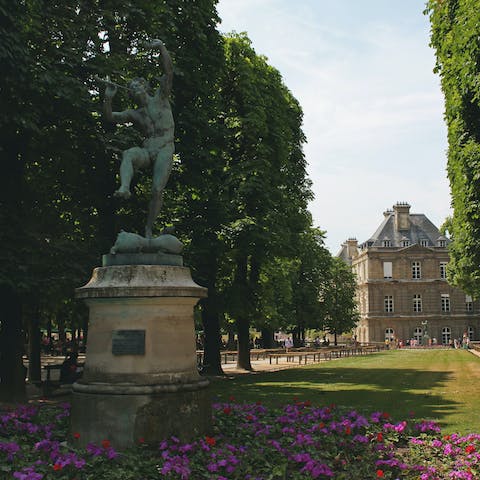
[0,285,26,402]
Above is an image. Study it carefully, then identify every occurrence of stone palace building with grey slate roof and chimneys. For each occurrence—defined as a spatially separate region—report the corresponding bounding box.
[338,203,480,344]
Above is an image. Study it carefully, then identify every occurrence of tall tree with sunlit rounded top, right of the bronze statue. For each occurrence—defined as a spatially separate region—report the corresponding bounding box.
[220,34,311,369]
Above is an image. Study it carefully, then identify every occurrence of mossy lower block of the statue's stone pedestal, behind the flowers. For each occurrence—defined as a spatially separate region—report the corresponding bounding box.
[71,388,212,450]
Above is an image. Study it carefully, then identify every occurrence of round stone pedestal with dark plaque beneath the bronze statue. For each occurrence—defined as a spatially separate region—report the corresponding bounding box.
[71,265,211,449]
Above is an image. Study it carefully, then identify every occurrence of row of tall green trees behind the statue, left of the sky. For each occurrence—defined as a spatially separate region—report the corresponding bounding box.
[0,0,356,402]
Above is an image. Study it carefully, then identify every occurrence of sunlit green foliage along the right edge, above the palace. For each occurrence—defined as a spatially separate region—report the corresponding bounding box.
[427,0,480,297]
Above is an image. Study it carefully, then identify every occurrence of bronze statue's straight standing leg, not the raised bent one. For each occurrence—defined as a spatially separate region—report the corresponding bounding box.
[145,144,174,238]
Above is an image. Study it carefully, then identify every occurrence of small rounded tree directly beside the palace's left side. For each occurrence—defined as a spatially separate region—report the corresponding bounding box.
[322,257,359,345]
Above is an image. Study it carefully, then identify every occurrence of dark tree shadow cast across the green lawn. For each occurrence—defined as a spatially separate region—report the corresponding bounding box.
[212,359,460,424]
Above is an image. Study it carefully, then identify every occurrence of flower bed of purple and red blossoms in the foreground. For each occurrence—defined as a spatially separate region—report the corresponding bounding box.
[0,400,480,480]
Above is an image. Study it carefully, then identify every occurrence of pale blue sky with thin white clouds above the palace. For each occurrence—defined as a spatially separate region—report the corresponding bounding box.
[217,0,451,254]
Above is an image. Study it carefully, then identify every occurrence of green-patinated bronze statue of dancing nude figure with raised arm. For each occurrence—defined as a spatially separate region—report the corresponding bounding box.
[104,39,175,238]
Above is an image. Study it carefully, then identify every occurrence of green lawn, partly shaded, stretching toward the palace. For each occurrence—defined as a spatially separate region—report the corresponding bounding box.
[212,350,480,434]
